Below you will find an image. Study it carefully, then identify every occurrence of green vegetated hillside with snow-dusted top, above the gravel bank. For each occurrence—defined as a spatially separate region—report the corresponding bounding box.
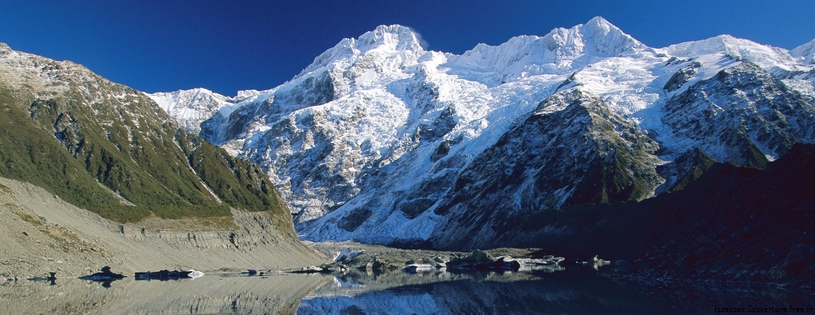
[0,60,290,226]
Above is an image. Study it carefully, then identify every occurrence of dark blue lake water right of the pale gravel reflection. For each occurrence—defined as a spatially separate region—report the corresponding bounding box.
[297,266,815,314]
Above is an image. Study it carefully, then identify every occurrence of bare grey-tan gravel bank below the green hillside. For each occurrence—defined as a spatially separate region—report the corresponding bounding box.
[0,178,330,279]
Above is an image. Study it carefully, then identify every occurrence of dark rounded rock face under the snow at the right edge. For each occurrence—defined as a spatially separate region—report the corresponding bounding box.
[662,62,815,168]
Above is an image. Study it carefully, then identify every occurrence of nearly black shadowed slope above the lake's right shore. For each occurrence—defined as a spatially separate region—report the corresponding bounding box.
[506,144,815,283]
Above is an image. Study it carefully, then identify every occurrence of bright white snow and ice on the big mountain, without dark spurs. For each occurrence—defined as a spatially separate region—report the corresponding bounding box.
[148,17,815,243]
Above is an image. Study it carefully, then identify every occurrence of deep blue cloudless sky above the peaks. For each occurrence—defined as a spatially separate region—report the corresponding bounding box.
[0,0,815,96]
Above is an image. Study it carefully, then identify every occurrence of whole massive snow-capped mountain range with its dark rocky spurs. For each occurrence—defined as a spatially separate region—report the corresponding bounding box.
[152,17,815,247]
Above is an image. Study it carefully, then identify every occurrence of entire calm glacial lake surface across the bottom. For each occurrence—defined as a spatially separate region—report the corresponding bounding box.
[0,267,815,314]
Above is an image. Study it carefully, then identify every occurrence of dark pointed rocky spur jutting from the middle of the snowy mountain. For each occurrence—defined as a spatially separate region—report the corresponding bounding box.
[431,90,662,248]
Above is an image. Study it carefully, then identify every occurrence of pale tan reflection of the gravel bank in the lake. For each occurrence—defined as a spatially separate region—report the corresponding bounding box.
[0,273,333,314]
